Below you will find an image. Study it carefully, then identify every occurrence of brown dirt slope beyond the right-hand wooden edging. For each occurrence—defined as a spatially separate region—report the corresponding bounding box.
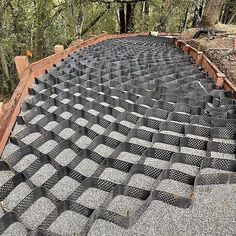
[181,24,236,85]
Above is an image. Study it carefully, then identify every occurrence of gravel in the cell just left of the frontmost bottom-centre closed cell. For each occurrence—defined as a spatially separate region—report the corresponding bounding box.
[76,188,109,209]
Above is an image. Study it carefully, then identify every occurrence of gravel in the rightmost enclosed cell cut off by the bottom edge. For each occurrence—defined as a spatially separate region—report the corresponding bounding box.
[48,210,88,236]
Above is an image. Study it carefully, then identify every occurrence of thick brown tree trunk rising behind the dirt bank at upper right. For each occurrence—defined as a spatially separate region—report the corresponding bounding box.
[201,0,224,28]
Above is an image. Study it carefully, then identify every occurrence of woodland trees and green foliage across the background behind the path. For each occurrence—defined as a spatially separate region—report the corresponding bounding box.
[0,0,236,99]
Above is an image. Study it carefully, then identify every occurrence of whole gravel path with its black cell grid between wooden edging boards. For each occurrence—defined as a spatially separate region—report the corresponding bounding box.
[0,36,236,236]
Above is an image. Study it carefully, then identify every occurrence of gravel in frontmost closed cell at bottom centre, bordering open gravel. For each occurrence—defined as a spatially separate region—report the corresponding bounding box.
[107,195,143,218]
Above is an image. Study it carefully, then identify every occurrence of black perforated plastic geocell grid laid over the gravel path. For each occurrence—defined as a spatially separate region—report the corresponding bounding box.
[0,36,236,236]
